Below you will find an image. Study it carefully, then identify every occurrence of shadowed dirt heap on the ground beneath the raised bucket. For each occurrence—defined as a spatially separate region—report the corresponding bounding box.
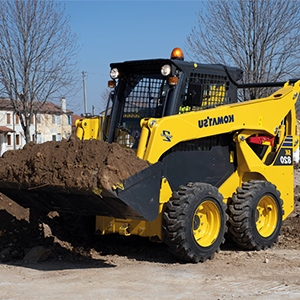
[0,193,89,262]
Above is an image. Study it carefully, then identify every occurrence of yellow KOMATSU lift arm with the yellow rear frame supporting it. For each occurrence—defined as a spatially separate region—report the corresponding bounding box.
[138,81,300,219]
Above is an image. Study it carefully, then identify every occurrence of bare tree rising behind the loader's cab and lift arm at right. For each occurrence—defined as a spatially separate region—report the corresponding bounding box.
[187,0,300,100]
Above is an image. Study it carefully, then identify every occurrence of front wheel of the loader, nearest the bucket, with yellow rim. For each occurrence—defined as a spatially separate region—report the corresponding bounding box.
[163,183,227,262]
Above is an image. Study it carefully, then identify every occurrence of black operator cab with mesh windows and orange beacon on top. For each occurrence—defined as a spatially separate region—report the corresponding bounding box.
[104,48,242,149]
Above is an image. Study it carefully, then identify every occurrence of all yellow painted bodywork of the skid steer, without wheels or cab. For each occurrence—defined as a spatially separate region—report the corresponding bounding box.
[77,81,300,241]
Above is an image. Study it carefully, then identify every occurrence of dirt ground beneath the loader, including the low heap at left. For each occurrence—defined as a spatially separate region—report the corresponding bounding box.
[0,142,300,300]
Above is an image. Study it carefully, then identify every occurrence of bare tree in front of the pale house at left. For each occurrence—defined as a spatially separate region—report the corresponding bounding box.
[0,0,78,143]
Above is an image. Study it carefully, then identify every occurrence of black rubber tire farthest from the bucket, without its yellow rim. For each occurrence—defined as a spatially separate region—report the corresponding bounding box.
[228,180,283,250]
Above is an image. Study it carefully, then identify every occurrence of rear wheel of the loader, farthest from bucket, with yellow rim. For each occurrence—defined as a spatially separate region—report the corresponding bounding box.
[229,181,283,250]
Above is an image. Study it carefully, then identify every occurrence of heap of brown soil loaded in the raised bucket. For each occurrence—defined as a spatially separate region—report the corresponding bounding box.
[0,135,149,189]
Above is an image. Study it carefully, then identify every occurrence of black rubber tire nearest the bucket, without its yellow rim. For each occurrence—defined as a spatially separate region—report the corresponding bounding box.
[163,183,227,263]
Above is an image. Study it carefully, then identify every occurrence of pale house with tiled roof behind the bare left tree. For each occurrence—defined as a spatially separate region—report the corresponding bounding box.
[0,98,73,155]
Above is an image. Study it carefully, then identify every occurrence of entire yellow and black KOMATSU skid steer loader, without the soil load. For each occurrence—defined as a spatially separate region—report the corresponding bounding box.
[0,48,300,262]
